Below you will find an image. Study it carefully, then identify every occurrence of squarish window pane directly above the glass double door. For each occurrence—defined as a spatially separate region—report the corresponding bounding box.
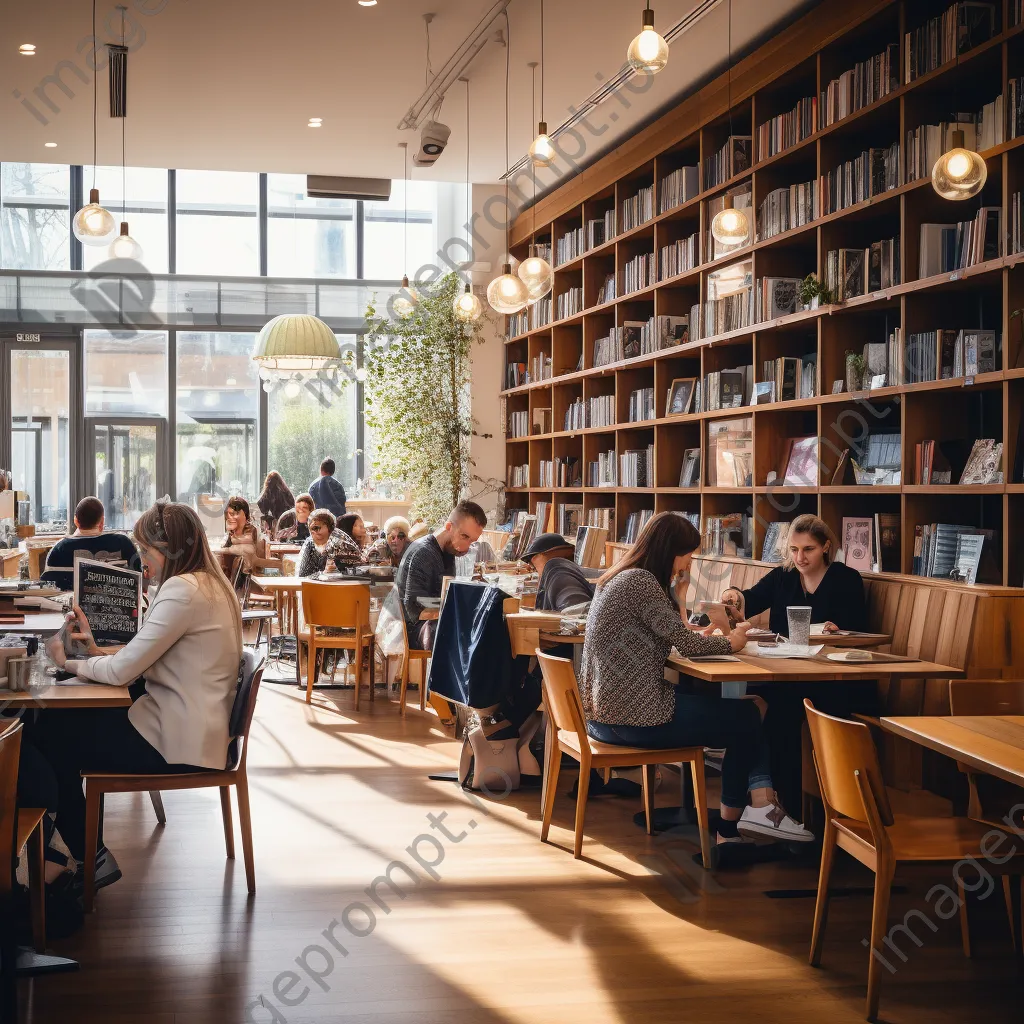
[83,331,167,419]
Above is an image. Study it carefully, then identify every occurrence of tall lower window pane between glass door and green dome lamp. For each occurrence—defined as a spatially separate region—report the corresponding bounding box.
[175,331,260,504]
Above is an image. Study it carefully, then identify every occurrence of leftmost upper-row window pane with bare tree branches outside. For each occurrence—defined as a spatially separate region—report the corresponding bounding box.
[0,164,71,270]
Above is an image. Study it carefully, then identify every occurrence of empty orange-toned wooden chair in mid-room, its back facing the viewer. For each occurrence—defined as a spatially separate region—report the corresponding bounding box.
[299,580,377,711]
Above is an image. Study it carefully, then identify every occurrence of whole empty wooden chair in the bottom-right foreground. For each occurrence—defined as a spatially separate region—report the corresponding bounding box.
[804,700,1024,1021]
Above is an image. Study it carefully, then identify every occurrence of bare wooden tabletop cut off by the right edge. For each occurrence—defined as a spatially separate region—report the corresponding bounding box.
[882,715,1024,786]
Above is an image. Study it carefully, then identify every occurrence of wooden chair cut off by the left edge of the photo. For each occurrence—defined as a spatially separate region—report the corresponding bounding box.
[0,720,46,953]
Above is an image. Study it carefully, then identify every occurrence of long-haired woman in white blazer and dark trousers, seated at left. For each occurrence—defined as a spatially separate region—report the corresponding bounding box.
[34,501,242,881]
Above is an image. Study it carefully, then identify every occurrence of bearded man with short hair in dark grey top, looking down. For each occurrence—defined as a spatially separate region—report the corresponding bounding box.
[394,502,487,650]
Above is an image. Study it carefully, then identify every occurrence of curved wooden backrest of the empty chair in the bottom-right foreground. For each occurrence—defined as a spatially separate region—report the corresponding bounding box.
[804,699,893,825]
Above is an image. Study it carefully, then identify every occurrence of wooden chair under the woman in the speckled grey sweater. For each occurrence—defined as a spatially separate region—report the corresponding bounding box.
[537,649,712,868]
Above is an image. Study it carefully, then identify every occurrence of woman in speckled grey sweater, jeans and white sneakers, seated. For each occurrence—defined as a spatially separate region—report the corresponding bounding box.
[580,512,813,842]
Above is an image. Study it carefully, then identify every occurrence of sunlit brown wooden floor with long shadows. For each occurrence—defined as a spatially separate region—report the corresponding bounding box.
[20,684,1024,1024]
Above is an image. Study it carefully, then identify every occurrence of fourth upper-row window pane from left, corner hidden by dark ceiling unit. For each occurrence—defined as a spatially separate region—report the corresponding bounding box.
[267,174,356,278]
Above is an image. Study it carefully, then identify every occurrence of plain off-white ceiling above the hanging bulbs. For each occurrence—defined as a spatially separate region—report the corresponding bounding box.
[0,0,806,181]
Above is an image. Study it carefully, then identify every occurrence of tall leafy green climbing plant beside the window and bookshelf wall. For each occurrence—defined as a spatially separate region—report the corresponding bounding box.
[365,273,493,523]
